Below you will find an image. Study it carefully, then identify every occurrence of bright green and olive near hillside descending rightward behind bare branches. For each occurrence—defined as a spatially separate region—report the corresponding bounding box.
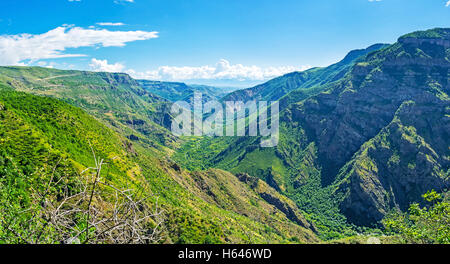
[0,91,317,243]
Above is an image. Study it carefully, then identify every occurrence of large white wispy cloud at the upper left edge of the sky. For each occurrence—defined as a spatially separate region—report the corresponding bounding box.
[0,25,158,65]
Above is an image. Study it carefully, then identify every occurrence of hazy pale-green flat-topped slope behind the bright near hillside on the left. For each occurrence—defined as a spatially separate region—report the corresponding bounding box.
[0,67,176,147]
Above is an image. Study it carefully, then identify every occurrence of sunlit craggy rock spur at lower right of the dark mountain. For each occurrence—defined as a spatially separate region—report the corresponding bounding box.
[340,103,450,225]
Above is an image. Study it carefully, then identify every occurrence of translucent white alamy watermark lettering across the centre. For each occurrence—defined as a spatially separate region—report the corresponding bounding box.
[171,93,279,147]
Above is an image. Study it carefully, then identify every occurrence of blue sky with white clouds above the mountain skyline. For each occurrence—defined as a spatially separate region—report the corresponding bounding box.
[0,0,450,86]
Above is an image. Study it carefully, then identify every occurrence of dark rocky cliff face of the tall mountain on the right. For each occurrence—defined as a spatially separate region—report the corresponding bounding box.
[283,27,450,224]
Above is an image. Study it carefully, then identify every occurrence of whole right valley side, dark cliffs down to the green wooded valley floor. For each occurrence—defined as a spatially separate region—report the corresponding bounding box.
[175,29,450,237]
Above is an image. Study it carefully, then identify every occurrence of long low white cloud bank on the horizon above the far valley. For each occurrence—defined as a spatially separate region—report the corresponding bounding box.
[126,59,310,81]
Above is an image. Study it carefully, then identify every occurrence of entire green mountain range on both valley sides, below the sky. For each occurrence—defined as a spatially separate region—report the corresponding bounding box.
[0,29,450,243]
